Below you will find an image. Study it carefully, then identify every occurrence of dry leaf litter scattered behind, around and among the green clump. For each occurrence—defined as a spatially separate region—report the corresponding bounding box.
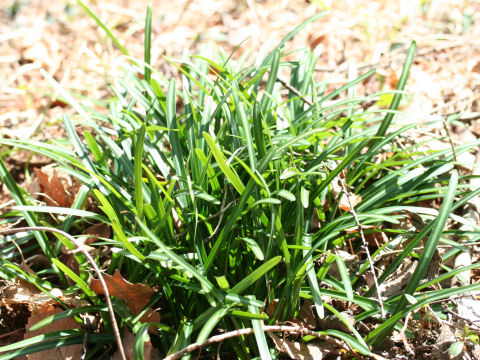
[0,0,480,358]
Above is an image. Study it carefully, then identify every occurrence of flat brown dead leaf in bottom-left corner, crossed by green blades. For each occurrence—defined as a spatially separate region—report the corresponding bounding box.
[24,305,83,360]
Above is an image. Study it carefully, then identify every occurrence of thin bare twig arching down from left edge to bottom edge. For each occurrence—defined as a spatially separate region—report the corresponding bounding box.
[0,226,127,360]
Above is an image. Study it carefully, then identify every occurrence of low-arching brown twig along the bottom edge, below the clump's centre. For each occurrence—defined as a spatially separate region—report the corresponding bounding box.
[163,325,352,360]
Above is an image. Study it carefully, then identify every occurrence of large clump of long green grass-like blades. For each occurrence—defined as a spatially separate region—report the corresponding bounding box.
[0,2,479,359]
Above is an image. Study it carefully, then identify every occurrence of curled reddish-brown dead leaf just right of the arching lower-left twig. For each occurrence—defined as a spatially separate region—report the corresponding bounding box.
[90,269,160,322]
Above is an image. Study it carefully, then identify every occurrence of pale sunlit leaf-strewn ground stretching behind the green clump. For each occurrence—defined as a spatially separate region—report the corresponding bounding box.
[0,0,480,358]
